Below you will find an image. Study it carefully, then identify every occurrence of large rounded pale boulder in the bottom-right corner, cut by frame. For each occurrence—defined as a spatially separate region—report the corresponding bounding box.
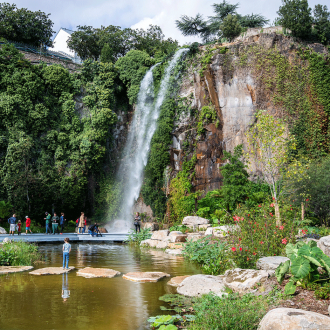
[258,308,330,330]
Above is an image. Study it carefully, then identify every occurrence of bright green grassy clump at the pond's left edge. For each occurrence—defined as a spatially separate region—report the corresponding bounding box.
[0,241,41,266]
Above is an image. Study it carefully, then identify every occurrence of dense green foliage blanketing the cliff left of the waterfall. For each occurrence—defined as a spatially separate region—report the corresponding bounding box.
[0,44,127,218]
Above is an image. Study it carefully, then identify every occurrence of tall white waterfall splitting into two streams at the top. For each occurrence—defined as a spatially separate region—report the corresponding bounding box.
[109,49,188,232]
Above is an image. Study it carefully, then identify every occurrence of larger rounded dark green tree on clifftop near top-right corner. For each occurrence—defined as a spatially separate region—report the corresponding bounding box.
[277,0,313,39]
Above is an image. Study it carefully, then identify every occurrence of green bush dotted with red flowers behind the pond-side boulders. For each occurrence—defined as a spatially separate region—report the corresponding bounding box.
[228,203,297,268]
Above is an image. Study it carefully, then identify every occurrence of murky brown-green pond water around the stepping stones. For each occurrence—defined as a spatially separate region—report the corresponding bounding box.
[0,244,201,330]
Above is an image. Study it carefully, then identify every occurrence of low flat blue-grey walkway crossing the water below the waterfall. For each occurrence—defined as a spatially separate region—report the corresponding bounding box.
[0,233,128,243]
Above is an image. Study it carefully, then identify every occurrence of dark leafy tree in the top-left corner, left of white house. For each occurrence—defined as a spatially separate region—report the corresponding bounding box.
[0,2,54,47]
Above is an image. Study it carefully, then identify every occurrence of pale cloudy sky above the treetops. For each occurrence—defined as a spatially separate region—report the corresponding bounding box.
[4,0,329,44]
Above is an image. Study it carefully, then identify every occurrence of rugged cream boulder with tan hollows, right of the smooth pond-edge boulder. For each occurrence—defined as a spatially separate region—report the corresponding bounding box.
[218,268,269,293]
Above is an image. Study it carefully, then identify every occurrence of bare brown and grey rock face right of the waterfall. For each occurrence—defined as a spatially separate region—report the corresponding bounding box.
[171,33,327,193]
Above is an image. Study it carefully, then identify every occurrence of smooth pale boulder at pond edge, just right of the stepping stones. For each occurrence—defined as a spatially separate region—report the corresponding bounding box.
[177,275,227,297]
